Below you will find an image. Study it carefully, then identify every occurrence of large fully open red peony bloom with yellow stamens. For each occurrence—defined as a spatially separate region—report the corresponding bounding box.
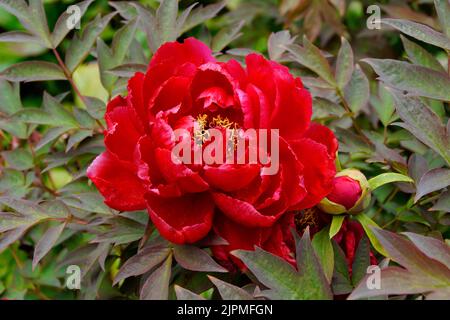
[87,38,337,263]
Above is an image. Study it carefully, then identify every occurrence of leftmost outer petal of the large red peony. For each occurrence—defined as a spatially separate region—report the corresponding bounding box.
[87,151,146,211]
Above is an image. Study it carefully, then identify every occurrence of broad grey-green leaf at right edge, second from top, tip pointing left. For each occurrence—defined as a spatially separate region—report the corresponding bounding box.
[362,59,450,101]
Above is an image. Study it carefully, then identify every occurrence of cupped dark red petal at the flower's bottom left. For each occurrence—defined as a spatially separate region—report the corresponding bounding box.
[145,193,214,244]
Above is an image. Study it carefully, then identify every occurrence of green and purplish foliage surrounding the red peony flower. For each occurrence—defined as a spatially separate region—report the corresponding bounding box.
[0,0,450,299]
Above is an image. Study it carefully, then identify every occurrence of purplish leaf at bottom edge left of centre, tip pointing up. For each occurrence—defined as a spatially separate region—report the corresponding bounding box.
[140,254,172,300]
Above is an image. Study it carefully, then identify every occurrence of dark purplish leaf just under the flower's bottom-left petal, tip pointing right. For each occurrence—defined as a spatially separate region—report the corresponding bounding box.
[173,245,227,272]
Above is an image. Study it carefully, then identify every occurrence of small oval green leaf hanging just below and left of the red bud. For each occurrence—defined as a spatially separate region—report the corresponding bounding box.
[311,228,334,283]
